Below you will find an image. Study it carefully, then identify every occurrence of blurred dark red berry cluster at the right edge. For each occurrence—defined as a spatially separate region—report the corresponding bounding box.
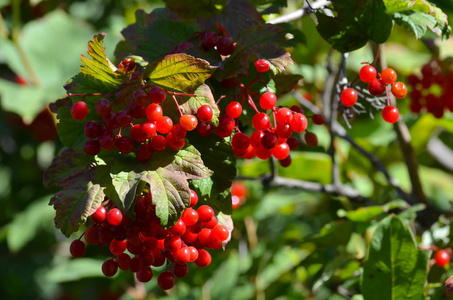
[407,60,453,118]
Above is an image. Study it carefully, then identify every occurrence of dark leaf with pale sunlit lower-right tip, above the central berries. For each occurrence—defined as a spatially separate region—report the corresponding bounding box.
[222,24,293,78]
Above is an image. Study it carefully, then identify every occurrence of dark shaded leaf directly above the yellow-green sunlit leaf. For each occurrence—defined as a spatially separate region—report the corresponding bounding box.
[115,8,200,62]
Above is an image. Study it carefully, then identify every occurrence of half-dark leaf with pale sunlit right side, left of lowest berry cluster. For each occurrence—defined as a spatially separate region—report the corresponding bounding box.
[49,166,105,237]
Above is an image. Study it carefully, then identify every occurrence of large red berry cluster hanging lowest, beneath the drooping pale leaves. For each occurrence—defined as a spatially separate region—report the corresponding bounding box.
[70,190,230,290]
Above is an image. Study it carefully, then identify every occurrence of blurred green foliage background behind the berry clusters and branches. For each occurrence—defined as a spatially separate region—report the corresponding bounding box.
[0,0,453,299]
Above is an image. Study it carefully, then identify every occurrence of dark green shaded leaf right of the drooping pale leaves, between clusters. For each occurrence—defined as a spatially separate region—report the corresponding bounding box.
[189,133,236,214]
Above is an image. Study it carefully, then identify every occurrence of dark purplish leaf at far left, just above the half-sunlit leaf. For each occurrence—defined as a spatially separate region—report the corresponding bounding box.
[43,148,94,188]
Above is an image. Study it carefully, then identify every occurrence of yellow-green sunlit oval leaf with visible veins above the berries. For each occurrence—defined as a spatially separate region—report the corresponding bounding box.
[145,53,215,92]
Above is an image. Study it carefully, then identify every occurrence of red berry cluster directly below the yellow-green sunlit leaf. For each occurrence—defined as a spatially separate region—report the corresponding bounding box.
[71,60,218,162]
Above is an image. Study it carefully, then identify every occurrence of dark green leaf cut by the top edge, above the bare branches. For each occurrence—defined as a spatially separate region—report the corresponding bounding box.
[316,0,392,52]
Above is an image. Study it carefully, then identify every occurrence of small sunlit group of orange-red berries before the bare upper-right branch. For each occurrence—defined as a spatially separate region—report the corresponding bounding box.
[340,64,407,123]
